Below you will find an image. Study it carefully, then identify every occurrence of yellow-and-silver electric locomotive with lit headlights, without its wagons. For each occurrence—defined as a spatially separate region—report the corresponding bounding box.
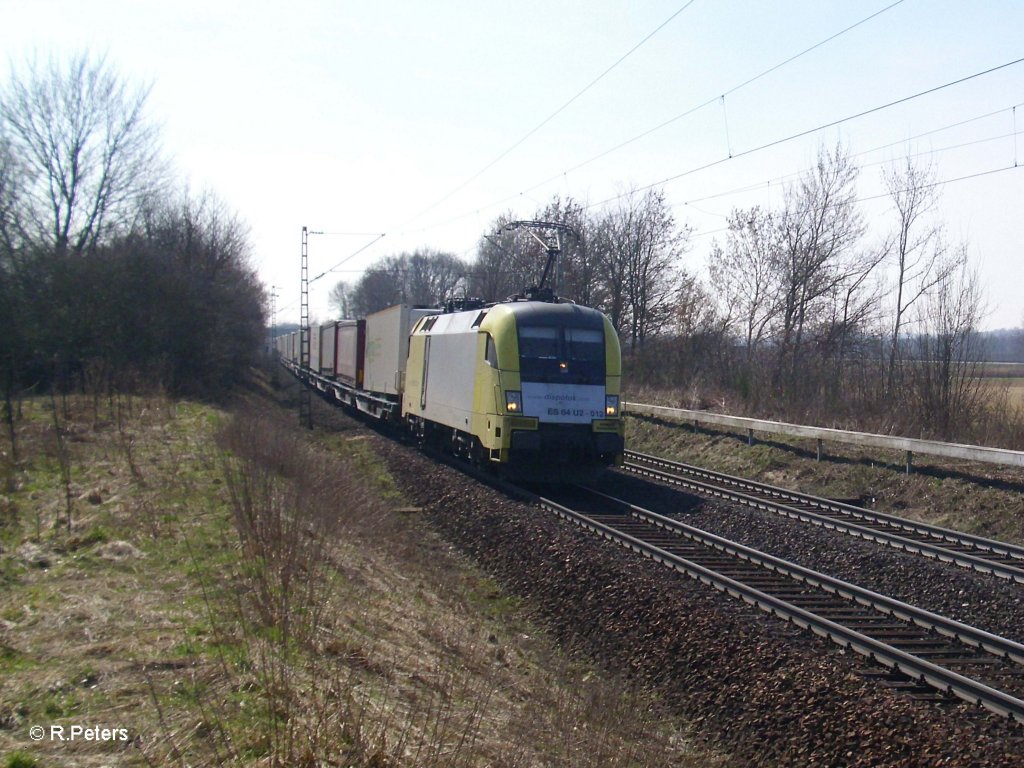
[401,296,625,481]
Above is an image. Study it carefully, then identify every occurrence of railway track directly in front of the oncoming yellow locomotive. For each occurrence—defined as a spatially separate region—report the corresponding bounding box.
[538,488,1024,723]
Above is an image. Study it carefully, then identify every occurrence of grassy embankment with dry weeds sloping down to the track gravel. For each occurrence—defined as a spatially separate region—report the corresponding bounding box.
[0,385,717,768]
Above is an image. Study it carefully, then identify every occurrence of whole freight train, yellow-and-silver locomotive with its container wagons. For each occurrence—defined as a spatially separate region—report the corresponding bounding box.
[275,298,625,481]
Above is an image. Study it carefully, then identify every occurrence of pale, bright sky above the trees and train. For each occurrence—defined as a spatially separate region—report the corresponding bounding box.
[0,0,1024,328]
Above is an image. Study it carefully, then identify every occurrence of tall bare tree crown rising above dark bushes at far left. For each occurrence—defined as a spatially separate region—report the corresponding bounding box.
[0,53,164,255]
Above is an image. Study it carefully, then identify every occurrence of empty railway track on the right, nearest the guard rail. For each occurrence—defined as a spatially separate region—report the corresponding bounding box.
[623,451,1024,584]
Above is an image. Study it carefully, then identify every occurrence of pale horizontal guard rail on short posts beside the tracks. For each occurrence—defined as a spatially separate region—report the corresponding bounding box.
[623,402,1024,474]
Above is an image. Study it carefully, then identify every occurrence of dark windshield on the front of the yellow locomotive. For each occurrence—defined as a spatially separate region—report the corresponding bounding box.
[519,326,605,385]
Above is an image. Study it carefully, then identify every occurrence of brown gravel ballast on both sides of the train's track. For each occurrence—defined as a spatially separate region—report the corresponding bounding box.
[368,439,1024,768]
